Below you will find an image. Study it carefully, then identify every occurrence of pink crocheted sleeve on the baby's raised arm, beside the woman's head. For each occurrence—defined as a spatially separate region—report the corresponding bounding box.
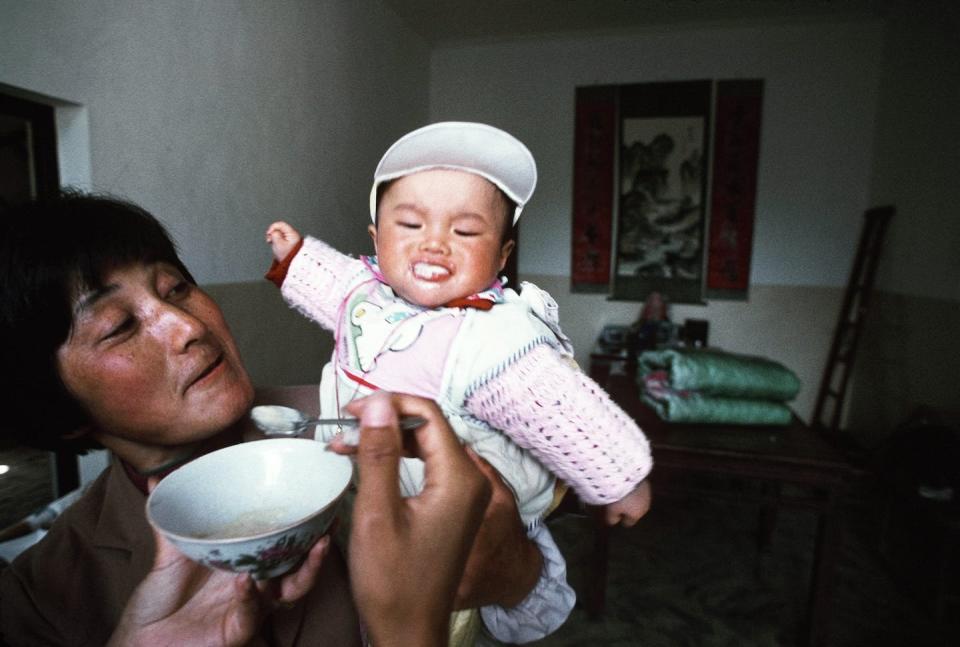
[280,236,368,330]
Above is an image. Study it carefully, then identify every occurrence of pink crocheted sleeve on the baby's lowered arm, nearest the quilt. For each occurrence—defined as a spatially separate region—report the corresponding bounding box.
[465,344,653,505]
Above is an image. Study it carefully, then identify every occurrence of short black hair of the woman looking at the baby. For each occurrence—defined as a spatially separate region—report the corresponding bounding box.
[0,192,194,452]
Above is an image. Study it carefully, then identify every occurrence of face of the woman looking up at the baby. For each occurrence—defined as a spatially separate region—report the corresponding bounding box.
[57,263,253,470]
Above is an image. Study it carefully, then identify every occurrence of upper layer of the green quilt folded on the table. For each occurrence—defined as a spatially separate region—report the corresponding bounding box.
[638,349,800,402]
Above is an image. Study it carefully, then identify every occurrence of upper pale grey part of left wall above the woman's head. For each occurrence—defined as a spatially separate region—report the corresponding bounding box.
[0,0,428,283]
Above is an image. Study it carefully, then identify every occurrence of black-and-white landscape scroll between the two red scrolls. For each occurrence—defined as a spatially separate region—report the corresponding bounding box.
[610,81,711,303]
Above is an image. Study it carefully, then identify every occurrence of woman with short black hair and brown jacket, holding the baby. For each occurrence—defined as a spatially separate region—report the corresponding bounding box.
[0,195,556,645]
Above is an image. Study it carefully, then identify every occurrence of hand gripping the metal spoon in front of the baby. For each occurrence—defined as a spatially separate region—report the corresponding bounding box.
[333,392,490,647]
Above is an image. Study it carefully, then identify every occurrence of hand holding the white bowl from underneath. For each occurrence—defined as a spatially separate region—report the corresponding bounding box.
[109,506,330,647]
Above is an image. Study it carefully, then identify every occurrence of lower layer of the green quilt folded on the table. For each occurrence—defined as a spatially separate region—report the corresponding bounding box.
[643,391,792,425]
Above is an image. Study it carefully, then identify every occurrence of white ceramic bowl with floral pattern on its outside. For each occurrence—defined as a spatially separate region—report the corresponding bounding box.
[147,438,353,579]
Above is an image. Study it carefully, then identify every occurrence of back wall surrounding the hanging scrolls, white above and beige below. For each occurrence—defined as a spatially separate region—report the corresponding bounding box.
[430,18,883,417]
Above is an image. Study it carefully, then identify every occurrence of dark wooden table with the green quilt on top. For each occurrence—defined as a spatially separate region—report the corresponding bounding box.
[584,368,852,646]
